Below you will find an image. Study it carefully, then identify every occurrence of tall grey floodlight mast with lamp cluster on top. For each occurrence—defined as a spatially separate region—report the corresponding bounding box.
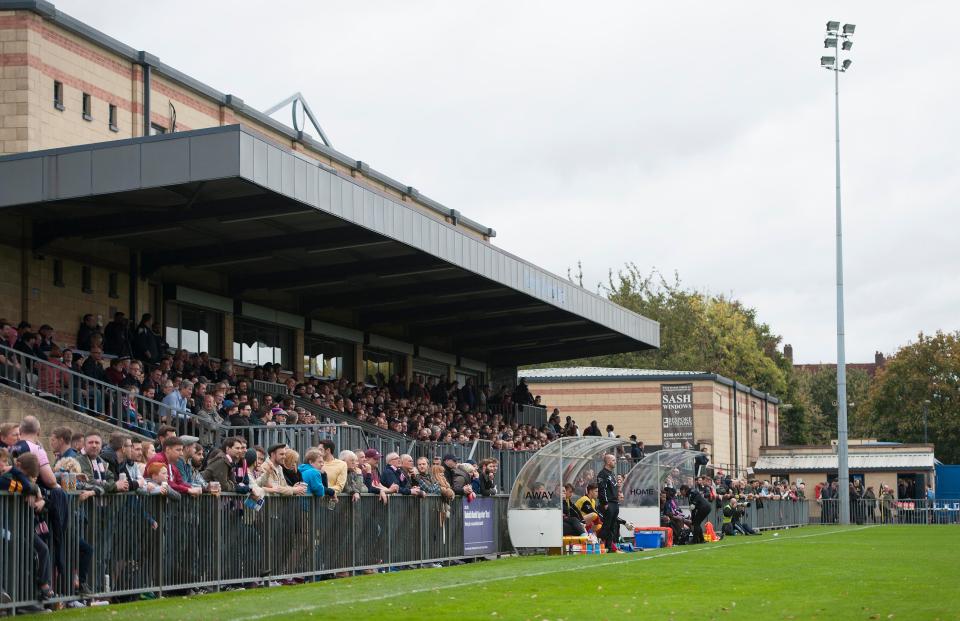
[820,21,856,524]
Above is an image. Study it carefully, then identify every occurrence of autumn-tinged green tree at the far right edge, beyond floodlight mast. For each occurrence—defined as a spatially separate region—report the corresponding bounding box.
[854,331,960,464]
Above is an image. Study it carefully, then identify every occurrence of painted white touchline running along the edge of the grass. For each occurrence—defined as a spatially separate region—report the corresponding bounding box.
[232,526,874,621]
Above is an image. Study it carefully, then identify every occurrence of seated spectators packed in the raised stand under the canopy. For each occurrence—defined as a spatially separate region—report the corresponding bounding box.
[0,313,580,451]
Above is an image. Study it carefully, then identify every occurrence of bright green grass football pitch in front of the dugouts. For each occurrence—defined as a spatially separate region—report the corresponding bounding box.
[56,526,960,621]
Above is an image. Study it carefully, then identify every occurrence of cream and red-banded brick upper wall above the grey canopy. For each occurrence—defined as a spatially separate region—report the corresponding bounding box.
[0,11,484,239]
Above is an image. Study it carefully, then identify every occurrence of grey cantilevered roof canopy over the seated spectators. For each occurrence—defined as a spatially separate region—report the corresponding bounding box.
[0,125,659,365]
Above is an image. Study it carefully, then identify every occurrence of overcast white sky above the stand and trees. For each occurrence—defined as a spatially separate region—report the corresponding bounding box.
[56,0,960,362]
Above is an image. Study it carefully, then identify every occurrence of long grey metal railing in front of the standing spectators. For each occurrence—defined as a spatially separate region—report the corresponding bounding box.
[0,494,513,609]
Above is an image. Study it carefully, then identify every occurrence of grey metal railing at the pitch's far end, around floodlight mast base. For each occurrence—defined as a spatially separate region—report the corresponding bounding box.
[809,498,960,524]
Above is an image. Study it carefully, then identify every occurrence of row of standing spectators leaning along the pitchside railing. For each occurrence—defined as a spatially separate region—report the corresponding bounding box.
[0,416,500,606]
